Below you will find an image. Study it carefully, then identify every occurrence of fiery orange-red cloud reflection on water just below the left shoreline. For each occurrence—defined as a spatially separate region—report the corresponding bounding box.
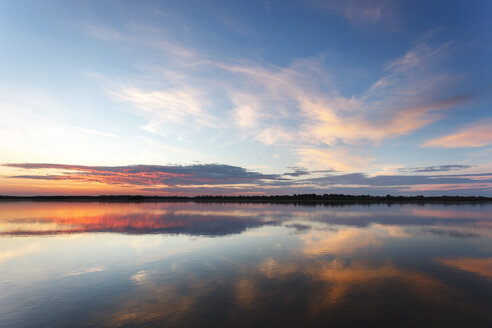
[0,202,270,235]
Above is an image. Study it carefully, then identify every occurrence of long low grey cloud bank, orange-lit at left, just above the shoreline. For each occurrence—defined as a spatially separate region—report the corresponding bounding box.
[4,163,492,195]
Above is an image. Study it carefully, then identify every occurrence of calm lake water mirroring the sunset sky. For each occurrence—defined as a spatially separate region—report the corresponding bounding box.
[0,202,492,327]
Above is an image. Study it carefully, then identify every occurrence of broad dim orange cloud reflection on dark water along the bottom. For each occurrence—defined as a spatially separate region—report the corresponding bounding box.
[99,258,466,327]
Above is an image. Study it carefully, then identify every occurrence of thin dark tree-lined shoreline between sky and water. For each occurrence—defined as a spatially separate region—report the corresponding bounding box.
[0,194,492,204]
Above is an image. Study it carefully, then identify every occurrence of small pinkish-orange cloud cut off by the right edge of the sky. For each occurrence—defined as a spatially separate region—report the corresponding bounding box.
[424,119,492,148]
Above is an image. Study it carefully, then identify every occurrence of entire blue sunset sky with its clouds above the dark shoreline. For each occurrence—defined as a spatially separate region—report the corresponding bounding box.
[0,0,492,196]
